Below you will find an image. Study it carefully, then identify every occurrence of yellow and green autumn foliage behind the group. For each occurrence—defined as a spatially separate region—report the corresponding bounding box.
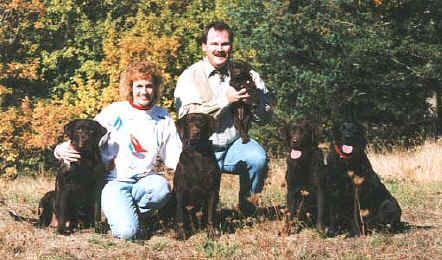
[0,0,442,177]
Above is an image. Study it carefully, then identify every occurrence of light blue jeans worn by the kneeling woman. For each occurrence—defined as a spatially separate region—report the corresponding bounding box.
[101,174,170,239]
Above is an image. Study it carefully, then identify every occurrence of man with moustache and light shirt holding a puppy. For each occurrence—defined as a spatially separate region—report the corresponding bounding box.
[174,22,271,214]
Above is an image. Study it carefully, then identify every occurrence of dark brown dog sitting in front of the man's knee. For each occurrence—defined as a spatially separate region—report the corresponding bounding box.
[173,113,221,240]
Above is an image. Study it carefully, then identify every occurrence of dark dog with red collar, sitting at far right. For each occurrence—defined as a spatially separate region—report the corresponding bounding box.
[327,121,401,236]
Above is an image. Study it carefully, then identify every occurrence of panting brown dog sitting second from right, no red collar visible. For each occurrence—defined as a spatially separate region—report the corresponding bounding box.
[281,120,325,233]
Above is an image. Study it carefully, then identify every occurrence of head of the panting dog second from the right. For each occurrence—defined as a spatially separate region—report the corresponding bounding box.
[280,120,318,160]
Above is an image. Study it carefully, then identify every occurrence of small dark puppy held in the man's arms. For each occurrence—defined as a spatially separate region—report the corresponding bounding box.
[230,61,258,143]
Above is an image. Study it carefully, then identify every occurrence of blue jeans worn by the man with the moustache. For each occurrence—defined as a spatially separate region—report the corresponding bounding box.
[215,138,269,199]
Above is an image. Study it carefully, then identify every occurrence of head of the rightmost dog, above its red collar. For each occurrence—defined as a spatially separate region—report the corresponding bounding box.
[333,121,367,157]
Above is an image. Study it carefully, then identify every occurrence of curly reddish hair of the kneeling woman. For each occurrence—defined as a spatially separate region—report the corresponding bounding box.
[119,61,163,104]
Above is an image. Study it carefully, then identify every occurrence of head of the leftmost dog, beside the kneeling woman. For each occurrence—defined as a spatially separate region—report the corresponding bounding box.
[64,119,107,152]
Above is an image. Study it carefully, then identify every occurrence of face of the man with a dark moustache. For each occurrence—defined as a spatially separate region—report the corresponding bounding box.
[202,28,232,68]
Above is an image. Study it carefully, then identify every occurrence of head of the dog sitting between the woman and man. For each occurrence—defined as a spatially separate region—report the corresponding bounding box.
[177,113,215,145]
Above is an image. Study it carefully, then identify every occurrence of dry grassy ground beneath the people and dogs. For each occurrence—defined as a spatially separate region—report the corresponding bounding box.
[0,143,442,259]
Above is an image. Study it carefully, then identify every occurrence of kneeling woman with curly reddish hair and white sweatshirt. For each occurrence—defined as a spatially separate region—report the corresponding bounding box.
[54,62,181,239]
